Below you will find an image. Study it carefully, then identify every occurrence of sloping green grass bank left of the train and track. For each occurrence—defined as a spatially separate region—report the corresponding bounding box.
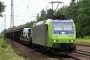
[0,36,30,60]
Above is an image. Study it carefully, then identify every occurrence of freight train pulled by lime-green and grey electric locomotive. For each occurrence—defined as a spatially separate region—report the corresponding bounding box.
[5,19,76,54]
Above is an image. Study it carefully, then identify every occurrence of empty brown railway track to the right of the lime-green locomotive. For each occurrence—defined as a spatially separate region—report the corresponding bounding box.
[70,44,90,60]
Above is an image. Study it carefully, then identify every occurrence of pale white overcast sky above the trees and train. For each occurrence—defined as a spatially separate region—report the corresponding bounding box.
[0,0,71,32]
